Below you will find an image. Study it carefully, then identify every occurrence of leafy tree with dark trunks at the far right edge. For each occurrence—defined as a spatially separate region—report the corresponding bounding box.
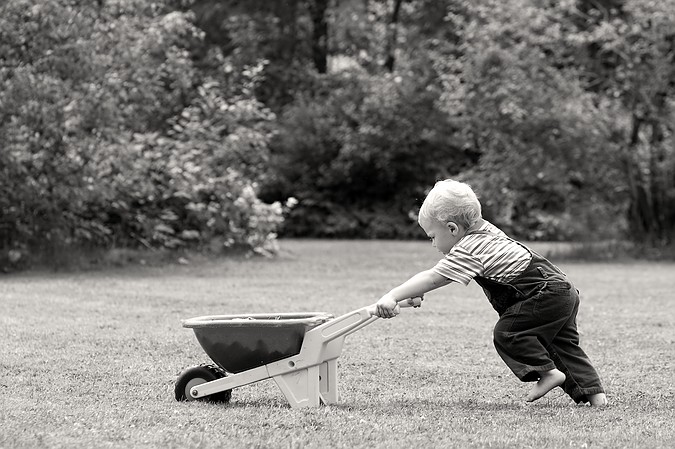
[566,0,675,246]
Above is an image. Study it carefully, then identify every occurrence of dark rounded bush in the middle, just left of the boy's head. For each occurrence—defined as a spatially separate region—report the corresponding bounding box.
[263,71,467,238]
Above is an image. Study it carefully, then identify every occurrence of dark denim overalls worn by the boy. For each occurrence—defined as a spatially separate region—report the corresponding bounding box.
[471,231,604,403]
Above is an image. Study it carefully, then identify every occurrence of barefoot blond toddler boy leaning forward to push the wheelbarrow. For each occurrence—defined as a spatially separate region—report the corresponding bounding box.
[377,180,607,406]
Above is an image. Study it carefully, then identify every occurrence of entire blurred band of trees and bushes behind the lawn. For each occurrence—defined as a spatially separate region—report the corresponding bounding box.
[0,0,675,266]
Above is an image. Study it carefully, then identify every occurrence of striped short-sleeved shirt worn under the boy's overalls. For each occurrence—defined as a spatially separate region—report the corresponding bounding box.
[432,221,532,285]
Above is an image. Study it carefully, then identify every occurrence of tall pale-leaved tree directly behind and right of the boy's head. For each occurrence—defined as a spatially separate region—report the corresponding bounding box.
[434,0,625,239]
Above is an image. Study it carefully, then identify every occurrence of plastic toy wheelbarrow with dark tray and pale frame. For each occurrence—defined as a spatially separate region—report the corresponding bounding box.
[175,297,423,408]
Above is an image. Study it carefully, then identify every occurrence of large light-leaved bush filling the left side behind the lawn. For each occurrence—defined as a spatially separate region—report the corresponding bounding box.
[0,0,282,267]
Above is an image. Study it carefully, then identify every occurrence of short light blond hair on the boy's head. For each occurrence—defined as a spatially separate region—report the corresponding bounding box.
[419,179,481,229]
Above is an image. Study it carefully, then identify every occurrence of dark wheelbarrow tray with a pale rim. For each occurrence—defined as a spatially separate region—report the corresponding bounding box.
[183,312,333,374]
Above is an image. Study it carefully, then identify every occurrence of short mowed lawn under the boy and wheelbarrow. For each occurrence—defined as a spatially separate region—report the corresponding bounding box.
[0,240,675,448]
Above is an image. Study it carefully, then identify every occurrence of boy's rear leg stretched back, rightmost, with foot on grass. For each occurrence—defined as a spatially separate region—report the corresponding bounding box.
[548,290,607,405]
